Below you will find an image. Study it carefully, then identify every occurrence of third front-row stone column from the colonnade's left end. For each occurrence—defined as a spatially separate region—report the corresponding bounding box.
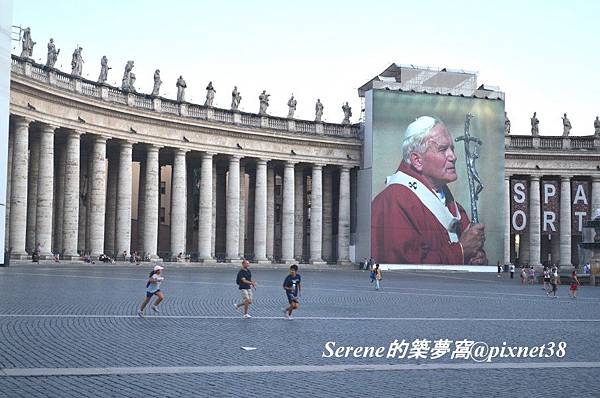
[58,131,81,260]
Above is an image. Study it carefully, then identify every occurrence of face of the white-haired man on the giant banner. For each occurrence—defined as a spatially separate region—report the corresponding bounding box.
[420,123,458,188]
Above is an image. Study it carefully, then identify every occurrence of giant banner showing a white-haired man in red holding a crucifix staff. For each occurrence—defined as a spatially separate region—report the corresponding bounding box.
[367,90,507,264]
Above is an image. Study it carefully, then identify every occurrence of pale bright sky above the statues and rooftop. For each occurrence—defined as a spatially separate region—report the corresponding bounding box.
[13,0,600,135]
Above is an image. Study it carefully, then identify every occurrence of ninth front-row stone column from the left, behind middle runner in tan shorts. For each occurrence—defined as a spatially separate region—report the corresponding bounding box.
[225,155,240,262]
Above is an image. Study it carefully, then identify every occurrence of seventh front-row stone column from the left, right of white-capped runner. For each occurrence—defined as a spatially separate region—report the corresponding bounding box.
[171,149,187,258]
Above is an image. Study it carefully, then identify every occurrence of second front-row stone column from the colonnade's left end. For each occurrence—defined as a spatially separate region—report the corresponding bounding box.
[35,125,56,257]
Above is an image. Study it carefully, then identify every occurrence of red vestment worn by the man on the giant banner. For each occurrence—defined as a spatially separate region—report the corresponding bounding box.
[371,162,469,264]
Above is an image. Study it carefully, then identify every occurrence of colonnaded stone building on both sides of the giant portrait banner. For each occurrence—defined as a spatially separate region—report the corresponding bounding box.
[5,55,600,265]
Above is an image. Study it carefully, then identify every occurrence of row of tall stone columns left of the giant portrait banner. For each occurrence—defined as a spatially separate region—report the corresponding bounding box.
[6,116,350,263]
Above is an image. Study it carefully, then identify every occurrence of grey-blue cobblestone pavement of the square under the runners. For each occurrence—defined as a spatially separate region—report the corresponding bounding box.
[0,264,600,397]
